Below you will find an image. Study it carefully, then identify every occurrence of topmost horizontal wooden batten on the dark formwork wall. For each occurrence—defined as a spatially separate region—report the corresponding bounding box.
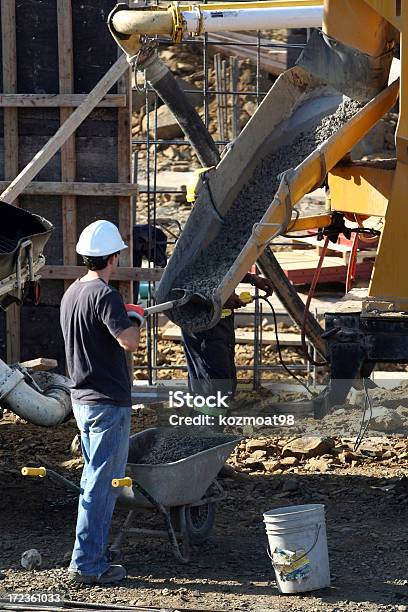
[0,93,126,108]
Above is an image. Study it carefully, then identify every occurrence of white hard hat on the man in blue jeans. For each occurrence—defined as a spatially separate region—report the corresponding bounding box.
[76,219,127,257]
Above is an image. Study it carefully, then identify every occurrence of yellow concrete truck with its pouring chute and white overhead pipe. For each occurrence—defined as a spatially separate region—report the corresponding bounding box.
[110,0,408,413]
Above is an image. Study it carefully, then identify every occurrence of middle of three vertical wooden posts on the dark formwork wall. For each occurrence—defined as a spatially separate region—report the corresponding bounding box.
[57,0,77,289]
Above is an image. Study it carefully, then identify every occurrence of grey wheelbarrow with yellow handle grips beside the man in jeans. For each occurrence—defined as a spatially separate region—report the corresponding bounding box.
[21,427,242,563]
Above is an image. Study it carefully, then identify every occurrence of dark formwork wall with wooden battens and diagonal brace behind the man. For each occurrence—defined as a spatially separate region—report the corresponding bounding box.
[0,0,137,367]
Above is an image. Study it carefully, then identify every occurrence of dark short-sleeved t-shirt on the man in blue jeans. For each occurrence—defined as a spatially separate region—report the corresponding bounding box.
[60,279,132,406]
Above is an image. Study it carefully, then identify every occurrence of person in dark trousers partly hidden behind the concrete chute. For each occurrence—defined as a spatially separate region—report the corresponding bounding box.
[182,274,273,417]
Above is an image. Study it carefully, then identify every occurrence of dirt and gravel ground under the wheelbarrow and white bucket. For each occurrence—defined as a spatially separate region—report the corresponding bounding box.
[0,414,408,612]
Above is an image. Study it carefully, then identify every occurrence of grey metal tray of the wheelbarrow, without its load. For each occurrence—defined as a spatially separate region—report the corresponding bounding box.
[118,427,242,508]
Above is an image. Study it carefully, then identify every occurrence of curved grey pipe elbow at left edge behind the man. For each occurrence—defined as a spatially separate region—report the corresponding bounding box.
[0,360,72,427]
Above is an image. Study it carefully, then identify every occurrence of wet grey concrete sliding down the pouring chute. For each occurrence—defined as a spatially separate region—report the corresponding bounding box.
[172,101,361,329]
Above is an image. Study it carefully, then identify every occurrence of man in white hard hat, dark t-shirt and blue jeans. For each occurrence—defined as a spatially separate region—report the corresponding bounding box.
[61,220,143,584]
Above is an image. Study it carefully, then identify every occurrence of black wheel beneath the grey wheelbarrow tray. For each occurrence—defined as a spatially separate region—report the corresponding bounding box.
[170,502,216,546]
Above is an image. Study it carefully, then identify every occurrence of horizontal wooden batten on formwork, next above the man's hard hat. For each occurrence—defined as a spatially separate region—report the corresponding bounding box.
[0,181,139,197]
